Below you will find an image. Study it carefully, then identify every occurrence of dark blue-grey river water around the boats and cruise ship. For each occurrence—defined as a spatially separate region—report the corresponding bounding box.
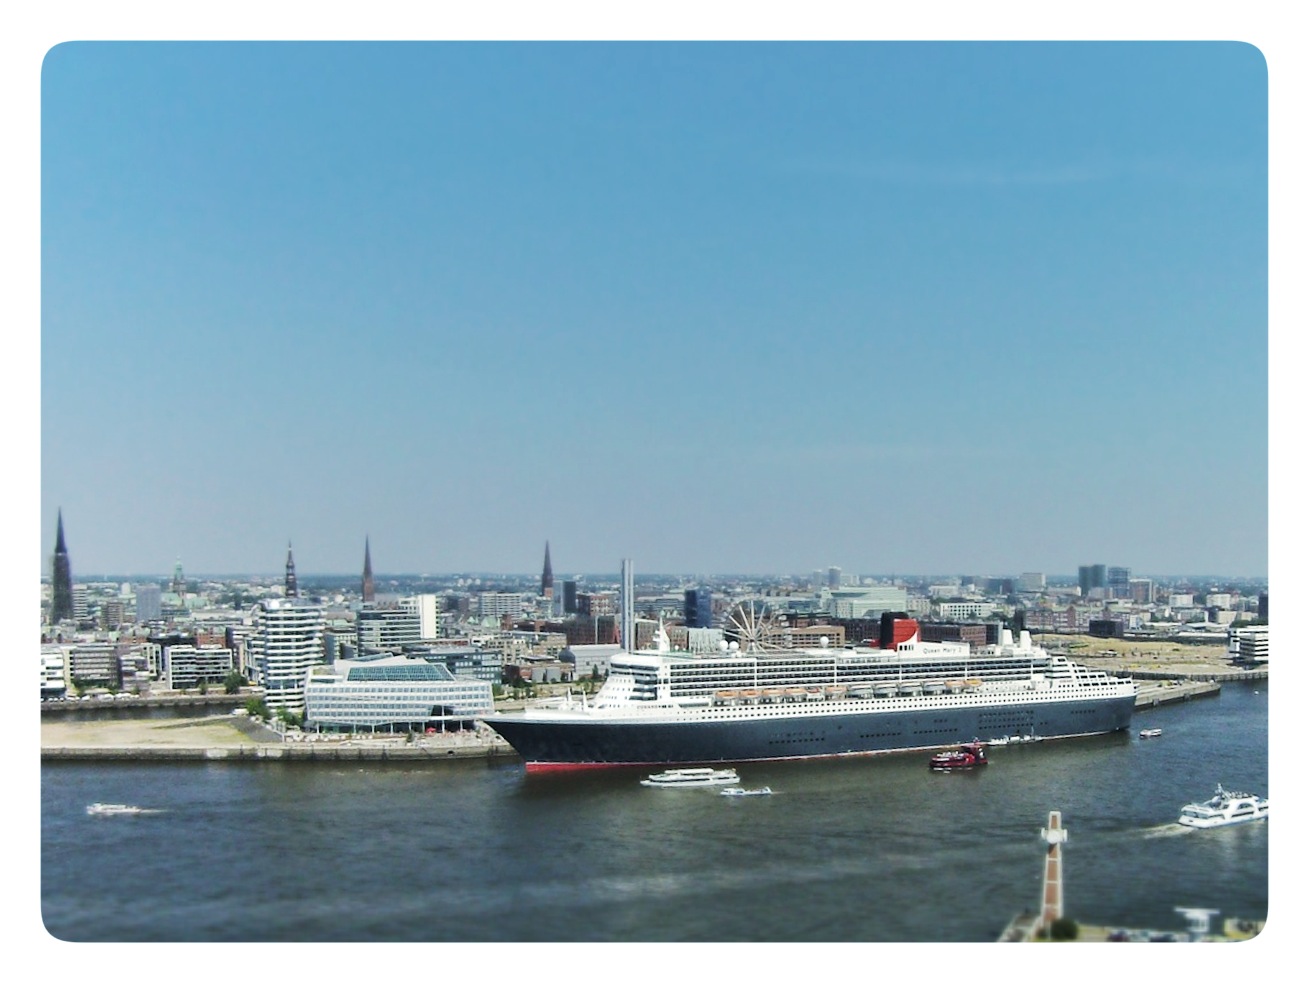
[41,681,1280,942]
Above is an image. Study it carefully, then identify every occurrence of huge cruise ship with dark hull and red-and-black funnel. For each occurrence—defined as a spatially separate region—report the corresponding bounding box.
[483,617,1136,772]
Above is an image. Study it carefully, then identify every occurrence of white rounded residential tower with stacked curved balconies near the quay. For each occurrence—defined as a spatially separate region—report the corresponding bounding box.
[246,597,323,713]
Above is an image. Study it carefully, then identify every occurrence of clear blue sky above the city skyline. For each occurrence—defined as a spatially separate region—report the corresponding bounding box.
[41,42,1268,576]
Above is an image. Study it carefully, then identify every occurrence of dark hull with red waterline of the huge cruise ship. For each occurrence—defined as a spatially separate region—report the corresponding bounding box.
[486,696,1135,771]
